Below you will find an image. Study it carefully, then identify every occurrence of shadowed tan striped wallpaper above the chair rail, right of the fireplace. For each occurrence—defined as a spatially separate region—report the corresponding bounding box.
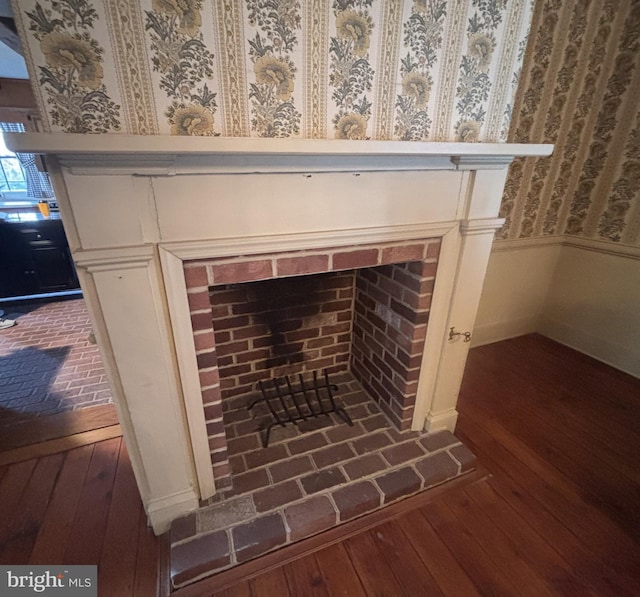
[499,0,640,246]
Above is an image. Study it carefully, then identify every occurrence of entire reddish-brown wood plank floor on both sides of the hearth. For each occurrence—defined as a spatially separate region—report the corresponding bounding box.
[0,335,640,597]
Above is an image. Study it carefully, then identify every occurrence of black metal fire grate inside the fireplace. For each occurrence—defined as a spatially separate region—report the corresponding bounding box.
[247,369,353,448]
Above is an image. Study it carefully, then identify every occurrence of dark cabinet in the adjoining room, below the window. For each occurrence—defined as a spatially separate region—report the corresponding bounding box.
[0,219,80,297]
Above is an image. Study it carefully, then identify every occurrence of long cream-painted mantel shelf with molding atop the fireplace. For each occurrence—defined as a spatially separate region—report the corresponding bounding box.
[5,133,553,176]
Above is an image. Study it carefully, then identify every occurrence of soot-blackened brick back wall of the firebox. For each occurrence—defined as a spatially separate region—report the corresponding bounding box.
[210,272,354,400]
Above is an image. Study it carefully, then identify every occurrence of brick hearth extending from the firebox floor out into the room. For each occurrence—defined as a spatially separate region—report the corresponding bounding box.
[171,373,475,587]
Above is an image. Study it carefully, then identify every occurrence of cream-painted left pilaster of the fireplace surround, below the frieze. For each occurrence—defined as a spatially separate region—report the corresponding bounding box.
[71,247,199,533]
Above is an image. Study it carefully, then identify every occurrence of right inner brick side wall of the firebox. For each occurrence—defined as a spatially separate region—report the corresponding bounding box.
[351,250,437,430]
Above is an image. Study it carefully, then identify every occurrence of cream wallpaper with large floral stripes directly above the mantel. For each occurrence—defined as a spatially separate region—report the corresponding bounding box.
[13,0,533,141]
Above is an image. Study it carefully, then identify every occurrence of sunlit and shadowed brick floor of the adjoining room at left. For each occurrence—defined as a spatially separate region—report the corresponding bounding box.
[0,298,111,427]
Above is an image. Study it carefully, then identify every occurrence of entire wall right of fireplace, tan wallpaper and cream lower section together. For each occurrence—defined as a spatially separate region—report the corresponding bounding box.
[474,0,640,375]
